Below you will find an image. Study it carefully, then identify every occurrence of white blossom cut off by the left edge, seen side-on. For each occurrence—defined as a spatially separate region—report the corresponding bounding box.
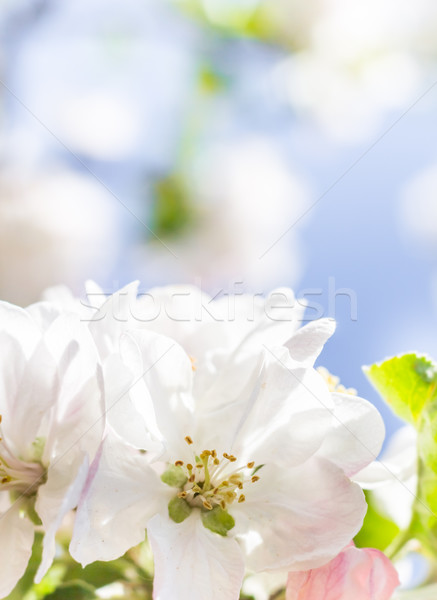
[0,303,104,597]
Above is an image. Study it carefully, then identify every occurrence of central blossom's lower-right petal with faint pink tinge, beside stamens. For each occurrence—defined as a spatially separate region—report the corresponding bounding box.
[230,458,367,571]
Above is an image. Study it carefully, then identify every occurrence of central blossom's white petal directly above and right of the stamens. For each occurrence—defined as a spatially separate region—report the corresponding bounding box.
[201,356,332,465]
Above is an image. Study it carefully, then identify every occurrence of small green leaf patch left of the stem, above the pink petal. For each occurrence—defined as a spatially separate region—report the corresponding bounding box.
[354,491,399,550]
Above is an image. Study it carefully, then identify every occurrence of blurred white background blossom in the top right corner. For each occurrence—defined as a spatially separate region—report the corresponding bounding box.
[277,0,437,142]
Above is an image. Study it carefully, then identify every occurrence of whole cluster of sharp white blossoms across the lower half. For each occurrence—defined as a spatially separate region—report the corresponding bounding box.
[0,283,384,600]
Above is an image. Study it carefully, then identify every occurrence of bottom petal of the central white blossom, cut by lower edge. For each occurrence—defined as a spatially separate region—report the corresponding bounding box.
[147,510,244,600]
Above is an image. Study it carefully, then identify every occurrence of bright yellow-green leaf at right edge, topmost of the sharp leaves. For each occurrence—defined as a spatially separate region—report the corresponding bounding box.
[364,354,437,427]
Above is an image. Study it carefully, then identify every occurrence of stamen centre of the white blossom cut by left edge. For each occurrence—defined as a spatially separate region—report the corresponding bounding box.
[0,415,45,496]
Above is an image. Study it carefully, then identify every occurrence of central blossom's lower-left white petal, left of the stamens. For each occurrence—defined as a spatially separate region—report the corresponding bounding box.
[70,435,168,566]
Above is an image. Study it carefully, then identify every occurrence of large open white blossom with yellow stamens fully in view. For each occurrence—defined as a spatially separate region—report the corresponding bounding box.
[70,307,384,600]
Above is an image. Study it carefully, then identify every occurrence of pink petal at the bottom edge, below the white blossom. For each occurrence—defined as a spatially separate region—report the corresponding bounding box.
[286,545,399,600]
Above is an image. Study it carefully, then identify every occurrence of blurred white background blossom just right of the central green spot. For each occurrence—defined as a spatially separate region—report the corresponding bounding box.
[135,136,310,289]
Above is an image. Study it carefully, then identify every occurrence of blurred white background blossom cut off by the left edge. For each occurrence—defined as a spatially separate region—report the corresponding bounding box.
[0,168,119,304]
